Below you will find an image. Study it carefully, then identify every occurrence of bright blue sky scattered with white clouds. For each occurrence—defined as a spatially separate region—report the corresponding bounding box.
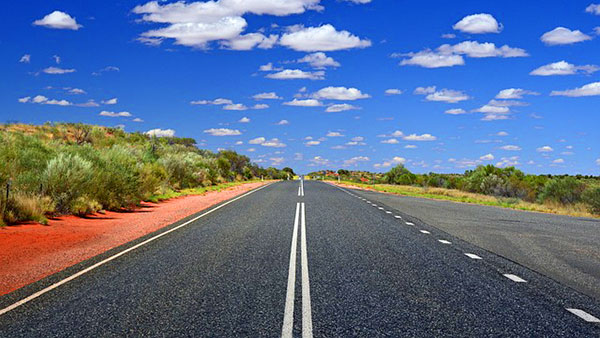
[0,0,600,175]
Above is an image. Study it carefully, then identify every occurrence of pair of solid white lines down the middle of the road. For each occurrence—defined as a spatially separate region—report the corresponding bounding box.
[281,203,313,338]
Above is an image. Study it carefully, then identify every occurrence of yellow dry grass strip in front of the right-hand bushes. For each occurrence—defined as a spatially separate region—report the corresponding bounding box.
[333,181,600,218]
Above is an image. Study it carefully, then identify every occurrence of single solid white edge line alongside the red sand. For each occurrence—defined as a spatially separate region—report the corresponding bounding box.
[0,183,272,316]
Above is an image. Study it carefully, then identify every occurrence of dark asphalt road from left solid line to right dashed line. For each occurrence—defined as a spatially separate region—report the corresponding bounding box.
[0,181,600,337]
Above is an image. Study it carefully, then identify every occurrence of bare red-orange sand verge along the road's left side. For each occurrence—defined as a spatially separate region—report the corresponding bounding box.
[0,182,264,295]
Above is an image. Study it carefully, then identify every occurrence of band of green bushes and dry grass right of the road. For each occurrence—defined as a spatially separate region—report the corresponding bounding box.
[309,165,600,216]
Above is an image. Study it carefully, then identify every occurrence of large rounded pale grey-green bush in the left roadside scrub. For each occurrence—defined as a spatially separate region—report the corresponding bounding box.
[43,153,94,213]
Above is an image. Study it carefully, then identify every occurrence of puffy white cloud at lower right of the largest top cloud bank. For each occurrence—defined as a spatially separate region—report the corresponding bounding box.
[280,24,371,52]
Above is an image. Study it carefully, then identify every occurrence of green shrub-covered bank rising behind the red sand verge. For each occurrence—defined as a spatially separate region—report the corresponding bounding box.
[0,124,289,224]
